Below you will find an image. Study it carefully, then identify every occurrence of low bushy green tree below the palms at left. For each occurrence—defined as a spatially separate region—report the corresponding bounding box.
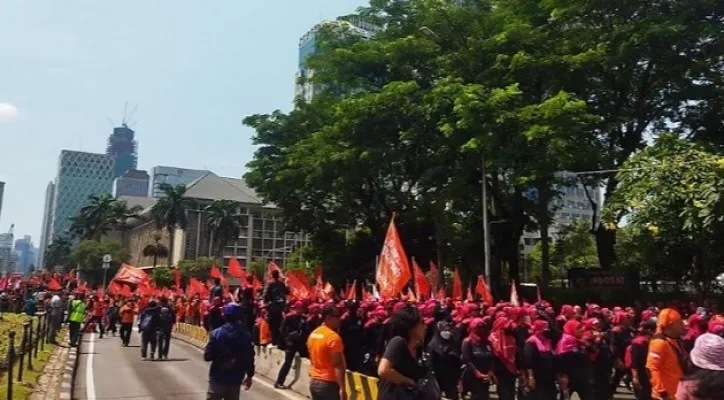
[71,240,130,286]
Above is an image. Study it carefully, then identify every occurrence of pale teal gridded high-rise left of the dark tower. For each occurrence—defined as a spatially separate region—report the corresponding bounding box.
[46,150,115,241]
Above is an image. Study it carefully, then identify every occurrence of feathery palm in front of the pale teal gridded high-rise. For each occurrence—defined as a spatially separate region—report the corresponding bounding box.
[69,193,116,242]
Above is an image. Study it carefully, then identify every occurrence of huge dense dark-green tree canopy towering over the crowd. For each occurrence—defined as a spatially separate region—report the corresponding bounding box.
[244,0,724,290]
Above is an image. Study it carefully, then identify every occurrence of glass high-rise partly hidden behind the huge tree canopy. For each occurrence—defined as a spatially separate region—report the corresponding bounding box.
[294,15,379,101]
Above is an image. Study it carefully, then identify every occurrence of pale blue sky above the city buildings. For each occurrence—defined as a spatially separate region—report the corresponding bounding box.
[0,0,367,242]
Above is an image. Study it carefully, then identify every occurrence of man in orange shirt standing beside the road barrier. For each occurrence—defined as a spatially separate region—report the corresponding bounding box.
[307,304,347,400]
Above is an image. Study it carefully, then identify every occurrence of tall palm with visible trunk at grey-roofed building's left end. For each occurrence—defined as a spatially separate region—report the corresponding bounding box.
[151,183,192,267]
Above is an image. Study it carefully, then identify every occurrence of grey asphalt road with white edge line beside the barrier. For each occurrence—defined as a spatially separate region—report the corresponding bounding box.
[73,331,302,400]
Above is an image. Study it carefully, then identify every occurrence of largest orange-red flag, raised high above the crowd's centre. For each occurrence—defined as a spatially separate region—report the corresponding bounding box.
[376,214,411,298]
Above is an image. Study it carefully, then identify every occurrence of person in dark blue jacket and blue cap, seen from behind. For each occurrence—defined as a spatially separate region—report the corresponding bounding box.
[204,303,254,400]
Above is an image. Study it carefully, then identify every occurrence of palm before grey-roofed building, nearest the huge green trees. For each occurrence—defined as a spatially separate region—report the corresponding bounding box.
[204,200,244,256]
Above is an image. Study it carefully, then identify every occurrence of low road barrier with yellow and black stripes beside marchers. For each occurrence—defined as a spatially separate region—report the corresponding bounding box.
[173,323,377,400]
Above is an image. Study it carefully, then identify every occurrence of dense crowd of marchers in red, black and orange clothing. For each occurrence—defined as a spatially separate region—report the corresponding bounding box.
[0,273,724,400]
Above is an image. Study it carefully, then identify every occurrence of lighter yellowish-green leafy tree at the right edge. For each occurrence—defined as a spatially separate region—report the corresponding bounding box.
[604,134,724,293]
